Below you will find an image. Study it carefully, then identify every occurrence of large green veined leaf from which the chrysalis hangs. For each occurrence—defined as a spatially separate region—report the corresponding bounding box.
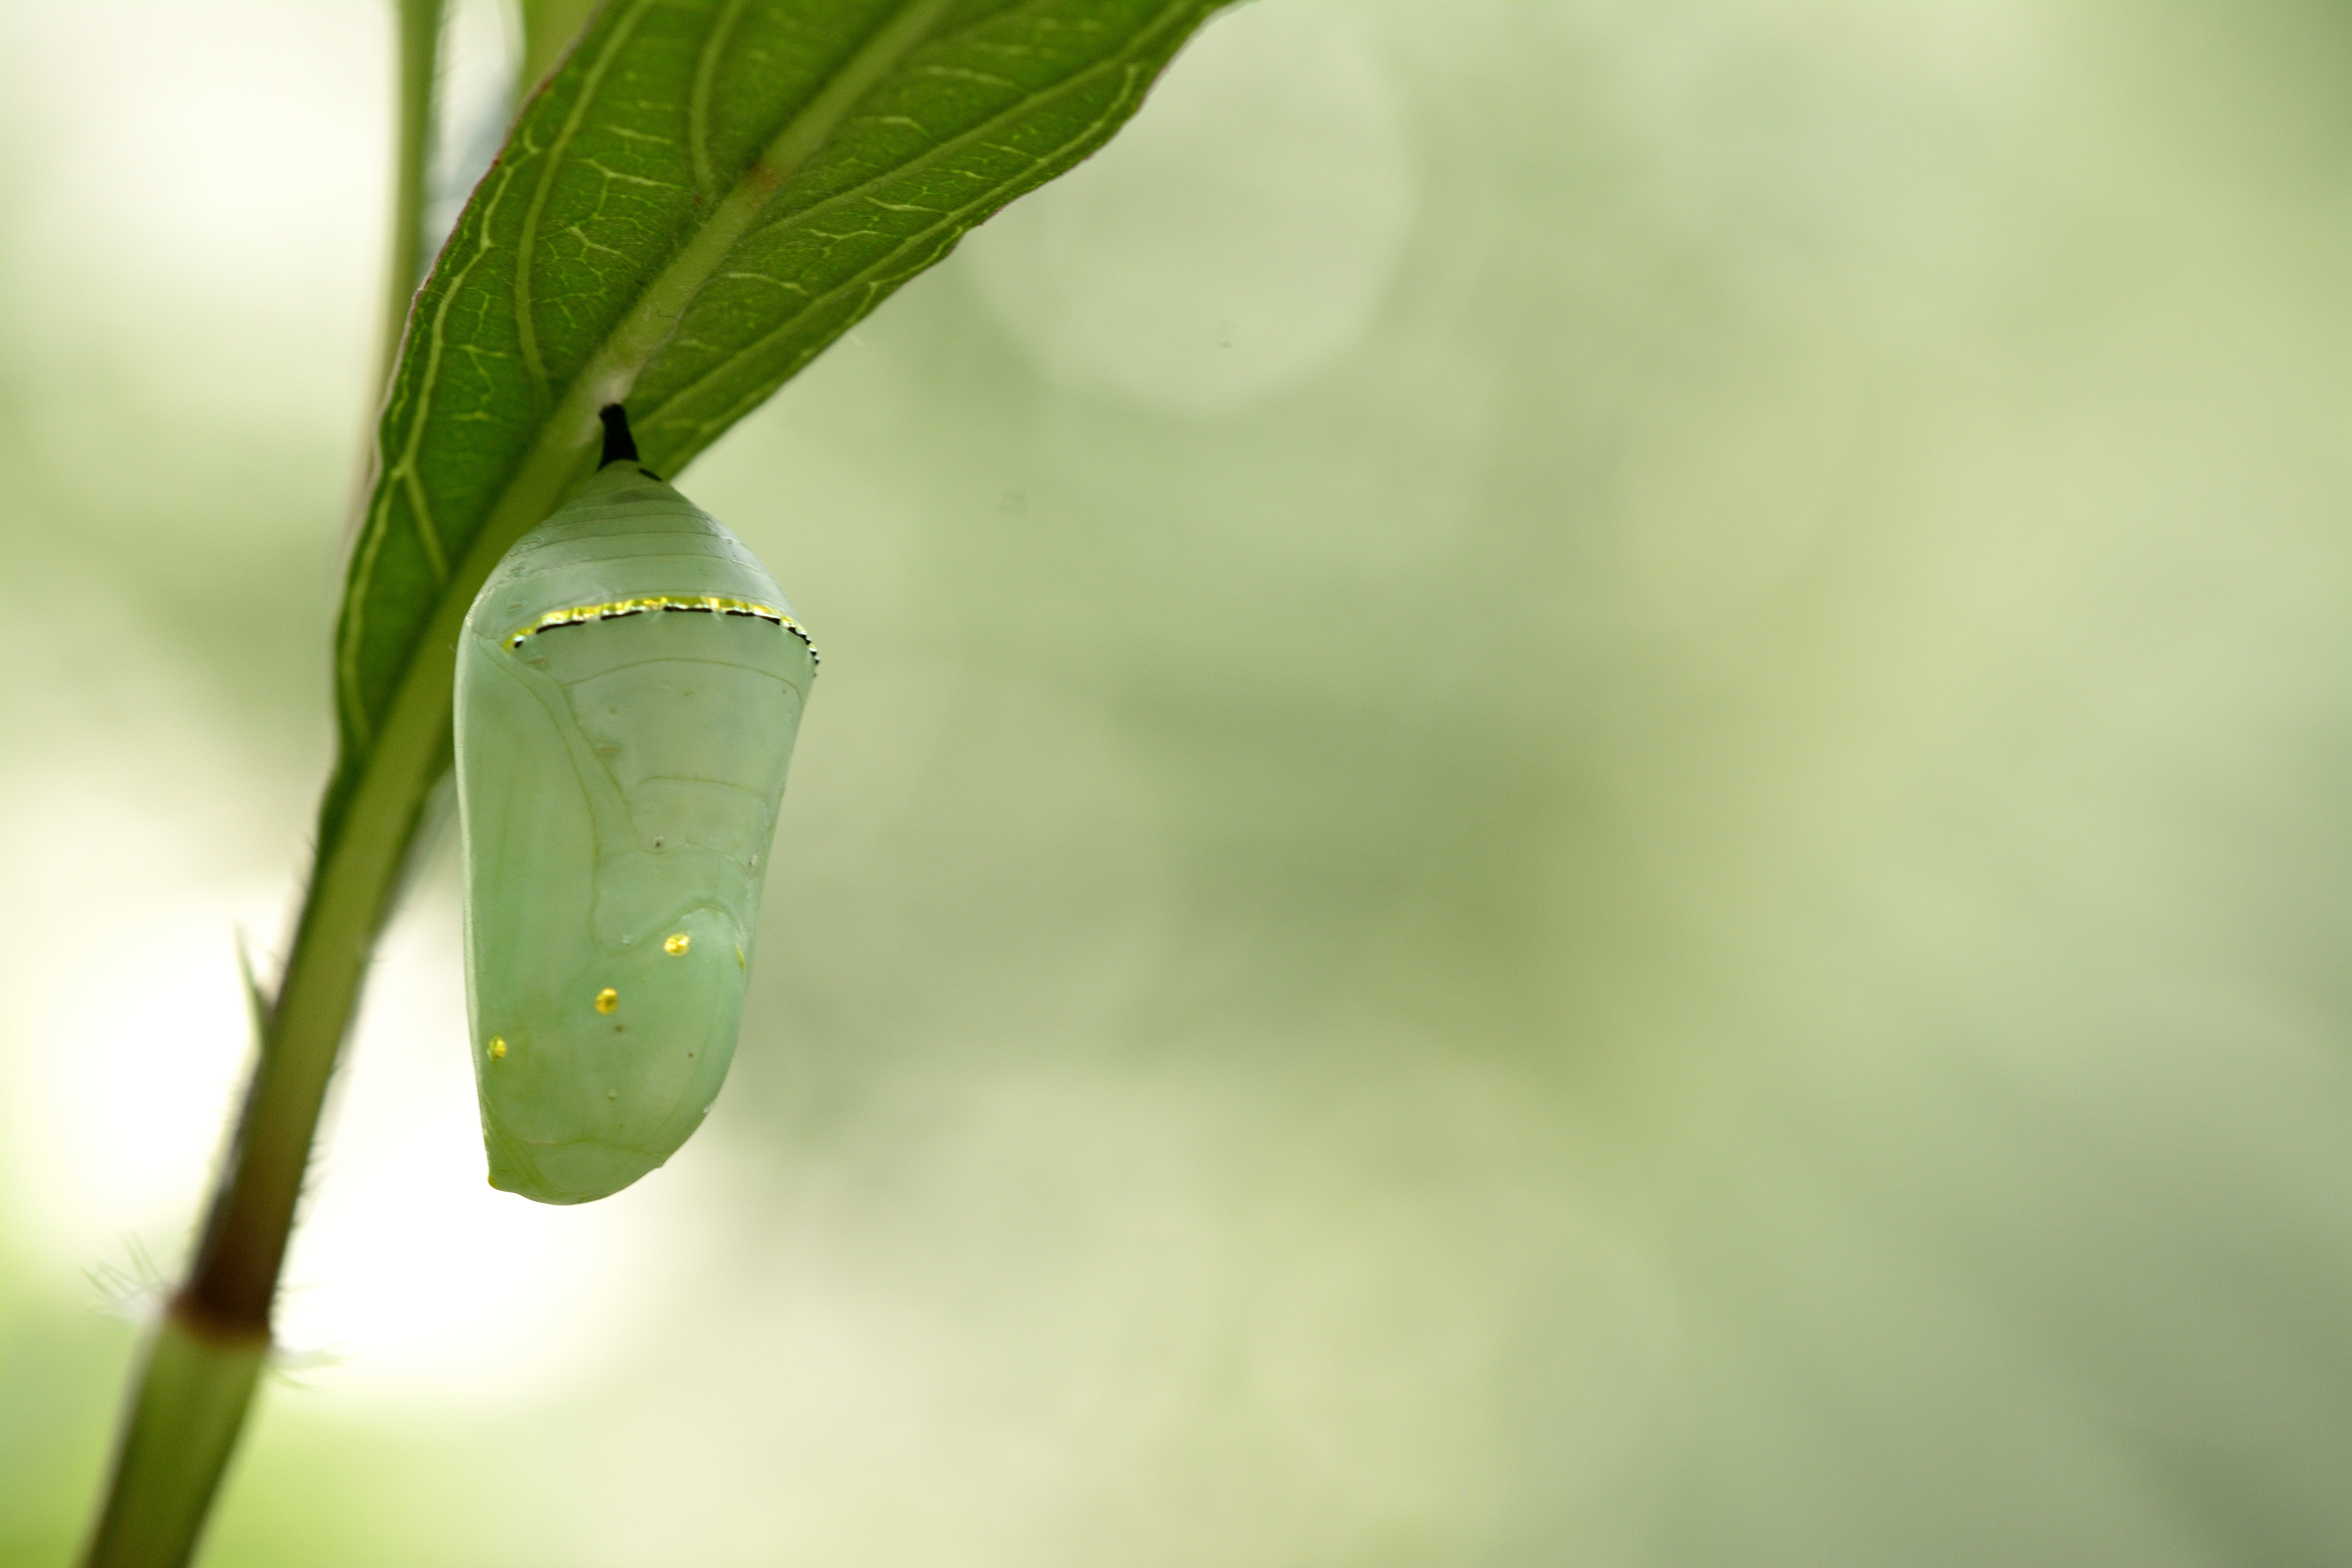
[320,0,1214,849]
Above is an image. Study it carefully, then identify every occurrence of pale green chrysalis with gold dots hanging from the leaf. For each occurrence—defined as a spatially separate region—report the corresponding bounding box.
[456,407,816,1203]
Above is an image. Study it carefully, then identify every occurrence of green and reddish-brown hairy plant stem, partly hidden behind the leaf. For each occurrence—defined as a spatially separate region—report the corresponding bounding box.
[82,0,447,1568]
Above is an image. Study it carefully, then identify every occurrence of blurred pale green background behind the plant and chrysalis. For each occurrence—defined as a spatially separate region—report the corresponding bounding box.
[0,0,2352,1568]
